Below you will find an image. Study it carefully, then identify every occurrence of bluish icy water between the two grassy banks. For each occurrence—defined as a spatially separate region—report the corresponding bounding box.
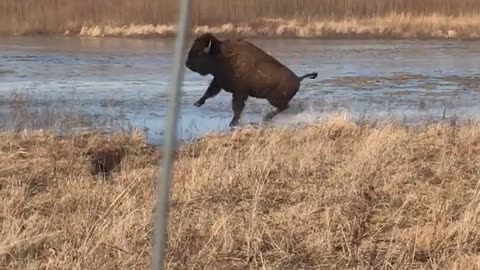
[0,37,480,143]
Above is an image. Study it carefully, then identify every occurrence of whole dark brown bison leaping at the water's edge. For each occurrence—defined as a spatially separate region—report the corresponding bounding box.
[186,33,317,127]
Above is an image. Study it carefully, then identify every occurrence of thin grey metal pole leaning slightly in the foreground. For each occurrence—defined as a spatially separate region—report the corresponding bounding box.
[152,0,191,270]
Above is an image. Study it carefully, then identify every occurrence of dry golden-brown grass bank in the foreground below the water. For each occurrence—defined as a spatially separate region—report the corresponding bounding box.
[0,118,480,269]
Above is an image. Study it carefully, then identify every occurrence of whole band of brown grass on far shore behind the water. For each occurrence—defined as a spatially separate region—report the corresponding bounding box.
[0,0,480,39]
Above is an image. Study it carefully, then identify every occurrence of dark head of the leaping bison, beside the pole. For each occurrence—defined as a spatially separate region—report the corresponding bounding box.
[185,33,221,76]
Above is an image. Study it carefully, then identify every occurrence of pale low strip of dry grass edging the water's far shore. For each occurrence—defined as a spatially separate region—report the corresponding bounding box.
[78,14,480,39]
